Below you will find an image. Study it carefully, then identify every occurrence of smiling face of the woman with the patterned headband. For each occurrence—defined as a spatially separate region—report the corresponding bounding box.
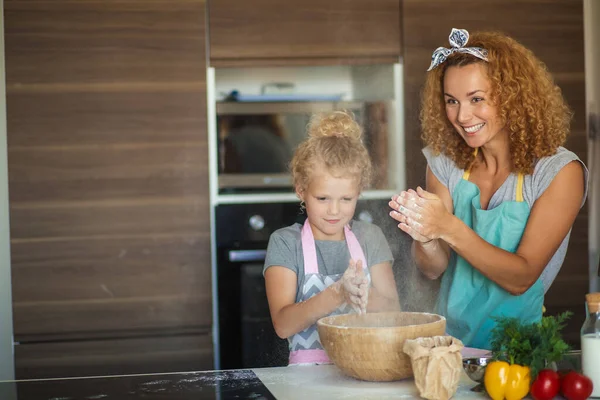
[443,63,508,148]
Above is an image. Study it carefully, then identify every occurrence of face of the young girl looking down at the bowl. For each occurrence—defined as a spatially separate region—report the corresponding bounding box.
[296,168,360,240]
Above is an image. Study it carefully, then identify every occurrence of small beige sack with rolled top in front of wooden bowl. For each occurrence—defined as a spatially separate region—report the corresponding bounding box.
[403,336,463,400]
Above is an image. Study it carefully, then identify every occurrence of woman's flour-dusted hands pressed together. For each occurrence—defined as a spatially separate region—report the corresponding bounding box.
[389,187,452,243]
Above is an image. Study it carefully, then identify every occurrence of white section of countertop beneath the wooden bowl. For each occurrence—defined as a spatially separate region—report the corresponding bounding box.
[252,365,486,400]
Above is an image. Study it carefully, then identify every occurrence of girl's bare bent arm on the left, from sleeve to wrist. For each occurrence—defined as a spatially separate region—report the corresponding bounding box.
[265,266,344,339]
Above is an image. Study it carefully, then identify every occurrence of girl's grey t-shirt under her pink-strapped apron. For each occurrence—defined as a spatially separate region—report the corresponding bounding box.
[263,221,393,302]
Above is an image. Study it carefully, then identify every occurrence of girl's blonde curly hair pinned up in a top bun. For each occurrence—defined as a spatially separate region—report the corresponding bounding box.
[290,111,372,191]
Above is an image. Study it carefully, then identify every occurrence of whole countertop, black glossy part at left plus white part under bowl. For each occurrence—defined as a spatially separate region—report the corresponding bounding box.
[0,365,485,400]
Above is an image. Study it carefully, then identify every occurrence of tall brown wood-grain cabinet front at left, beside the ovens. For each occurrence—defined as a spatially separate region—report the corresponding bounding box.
[4,0,212,378]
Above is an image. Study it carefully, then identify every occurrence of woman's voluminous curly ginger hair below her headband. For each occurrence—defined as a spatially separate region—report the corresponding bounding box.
[420,32,572,174]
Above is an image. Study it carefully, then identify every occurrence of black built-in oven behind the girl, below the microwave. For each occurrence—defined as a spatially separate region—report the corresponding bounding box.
[215,199,393,369]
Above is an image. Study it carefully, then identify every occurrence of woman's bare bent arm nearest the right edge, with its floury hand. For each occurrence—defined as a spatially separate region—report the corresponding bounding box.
[408,161,584,295]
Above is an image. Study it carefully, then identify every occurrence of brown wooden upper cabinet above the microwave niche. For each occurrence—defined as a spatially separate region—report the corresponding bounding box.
[209,0,401,66]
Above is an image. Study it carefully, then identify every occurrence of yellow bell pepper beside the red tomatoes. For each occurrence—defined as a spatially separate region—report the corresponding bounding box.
[483,361,531,400]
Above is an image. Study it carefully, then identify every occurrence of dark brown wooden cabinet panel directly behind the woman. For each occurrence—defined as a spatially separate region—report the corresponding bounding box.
[403,0,588,345]
